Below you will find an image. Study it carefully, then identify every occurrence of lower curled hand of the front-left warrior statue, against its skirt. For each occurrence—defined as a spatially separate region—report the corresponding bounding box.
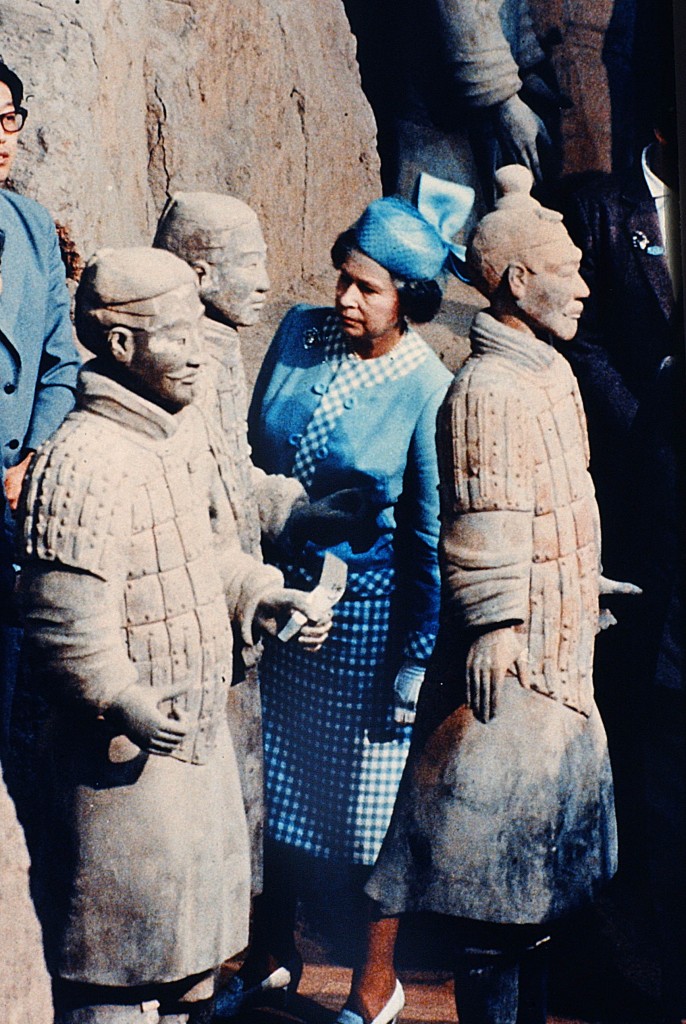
[106,683,188,756]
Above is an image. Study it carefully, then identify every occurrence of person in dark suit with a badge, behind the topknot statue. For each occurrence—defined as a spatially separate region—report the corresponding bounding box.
[560,143,686,1019]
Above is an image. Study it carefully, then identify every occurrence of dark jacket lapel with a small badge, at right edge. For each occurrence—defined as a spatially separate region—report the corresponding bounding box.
[623,167,675,321]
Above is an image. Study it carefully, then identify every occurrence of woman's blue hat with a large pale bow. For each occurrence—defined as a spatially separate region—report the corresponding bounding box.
[353,173,474,281]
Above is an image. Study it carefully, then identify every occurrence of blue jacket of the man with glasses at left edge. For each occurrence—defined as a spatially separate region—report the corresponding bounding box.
[0,189,81,473]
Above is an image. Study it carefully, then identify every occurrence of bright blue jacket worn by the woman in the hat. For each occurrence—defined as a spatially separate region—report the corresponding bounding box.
[249,305,453,657]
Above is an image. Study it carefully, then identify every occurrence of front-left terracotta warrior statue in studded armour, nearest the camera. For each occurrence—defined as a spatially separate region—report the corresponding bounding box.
[14,249,328,1024]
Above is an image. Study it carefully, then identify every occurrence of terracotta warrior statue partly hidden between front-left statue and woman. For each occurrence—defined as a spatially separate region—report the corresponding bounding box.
[153,191,355,892]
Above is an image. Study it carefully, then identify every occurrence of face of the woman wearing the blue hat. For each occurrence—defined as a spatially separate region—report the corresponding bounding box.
[336,251,402,354]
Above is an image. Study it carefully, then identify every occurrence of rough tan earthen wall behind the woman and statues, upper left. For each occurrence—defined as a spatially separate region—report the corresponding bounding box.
[0,0,380,293]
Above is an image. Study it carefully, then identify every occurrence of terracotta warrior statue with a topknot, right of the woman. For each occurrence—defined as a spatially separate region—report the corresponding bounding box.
[368,166,638,1024]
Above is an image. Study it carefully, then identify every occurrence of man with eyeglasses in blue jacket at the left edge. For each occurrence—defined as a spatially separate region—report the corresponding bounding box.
[0,57,80,753]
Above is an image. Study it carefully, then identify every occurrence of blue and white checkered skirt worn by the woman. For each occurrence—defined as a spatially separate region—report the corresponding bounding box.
[260,569,412,864]
